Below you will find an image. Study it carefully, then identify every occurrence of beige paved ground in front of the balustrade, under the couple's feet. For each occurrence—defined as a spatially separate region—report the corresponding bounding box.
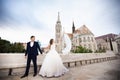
[0,59,120,80]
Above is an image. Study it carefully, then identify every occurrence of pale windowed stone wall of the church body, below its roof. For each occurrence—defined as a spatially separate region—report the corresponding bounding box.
[73,34,97,52]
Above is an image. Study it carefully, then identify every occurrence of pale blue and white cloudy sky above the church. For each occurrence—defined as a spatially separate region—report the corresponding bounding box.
[0,0,120,43]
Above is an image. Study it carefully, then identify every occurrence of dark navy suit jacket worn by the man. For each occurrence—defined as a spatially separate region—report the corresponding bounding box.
[25,42,42,56]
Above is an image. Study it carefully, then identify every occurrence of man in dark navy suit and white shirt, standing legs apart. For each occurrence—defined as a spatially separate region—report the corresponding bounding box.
[21,36,42,78]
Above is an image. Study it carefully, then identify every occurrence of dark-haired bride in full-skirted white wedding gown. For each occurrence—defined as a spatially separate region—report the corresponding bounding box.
[39,39,68,77]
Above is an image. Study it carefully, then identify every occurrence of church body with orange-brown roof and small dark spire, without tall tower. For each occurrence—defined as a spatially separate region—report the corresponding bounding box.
[68,22,97,52]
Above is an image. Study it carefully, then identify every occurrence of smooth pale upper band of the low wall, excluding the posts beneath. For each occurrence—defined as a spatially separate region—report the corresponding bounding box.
[0,52,115,68]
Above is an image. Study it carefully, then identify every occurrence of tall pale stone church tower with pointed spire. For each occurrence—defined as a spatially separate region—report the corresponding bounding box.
[55,12,62,53]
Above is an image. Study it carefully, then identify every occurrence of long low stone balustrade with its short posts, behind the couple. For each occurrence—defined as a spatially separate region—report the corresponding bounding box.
[0,52,116,75]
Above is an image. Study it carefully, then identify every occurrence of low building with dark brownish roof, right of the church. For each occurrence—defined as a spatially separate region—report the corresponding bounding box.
[95,33,118,53]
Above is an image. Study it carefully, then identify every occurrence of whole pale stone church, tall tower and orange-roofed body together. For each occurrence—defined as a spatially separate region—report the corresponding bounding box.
[55,13,97,53]
